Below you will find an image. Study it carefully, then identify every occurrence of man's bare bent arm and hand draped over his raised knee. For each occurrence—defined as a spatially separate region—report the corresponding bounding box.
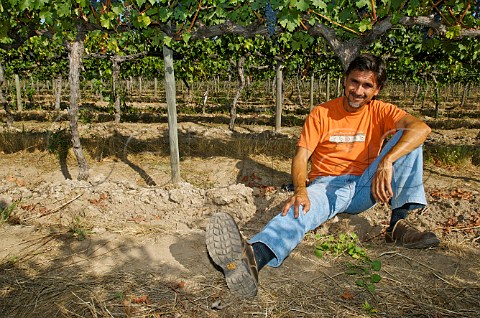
[372,114,431,203]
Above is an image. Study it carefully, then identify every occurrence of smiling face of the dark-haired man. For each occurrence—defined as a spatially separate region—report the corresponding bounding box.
[343,70,380,112]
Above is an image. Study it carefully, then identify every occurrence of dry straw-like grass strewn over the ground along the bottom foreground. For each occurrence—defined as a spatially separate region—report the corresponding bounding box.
[0,235,480,317]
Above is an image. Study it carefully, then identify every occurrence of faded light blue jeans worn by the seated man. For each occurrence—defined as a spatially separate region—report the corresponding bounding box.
[249,131,427,267]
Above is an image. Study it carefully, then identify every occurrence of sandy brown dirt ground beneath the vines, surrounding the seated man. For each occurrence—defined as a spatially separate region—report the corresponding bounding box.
[0,122,480,317]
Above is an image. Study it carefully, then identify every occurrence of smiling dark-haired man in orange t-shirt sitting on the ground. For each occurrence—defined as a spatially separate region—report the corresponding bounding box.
[206,54,439,297]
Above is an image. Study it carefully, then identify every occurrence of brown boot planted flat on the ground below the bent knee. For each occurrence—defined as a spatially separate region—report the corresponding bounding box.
[385,220,440,248]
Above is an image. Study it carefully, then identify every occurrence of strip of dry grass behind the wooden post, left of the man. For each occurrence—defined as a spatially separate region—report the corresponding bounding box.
[0,117,297,160]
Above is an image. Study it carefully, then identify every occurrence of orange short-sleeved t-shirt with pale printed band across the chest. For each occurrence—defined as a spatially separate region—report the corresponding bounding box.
[298,97,406,180]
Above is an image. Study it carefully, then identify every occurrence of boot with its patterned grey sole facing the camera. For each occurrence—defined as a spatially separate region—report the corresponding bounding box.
[206,213,258,297]
